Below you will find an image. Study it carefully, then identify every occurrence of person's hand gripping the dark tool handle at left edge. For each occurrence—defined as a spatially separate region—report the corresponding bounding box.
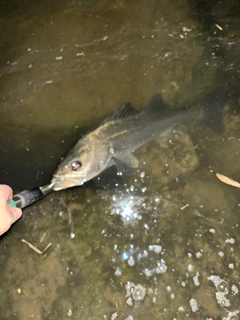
[0,184,22,236]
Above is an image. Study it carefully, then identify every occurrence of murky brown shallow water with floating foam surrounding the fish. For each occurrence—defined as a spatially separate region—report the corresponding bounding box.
[0,0,240,320]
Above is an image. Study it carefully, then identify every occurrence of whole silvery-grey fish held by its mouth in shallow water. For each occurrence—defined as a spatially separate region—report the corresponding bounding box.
[51,90,225,191]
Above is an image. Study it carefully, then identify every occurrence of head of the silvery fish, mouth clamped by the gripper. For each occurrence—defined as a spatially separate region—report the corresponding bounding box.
[51,142,110,191]
